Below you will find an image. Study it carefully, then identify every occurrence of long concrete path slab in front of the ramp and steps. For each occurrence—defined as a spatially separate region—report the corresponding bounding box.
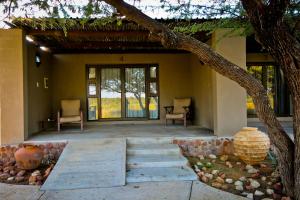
[41,181,192,200]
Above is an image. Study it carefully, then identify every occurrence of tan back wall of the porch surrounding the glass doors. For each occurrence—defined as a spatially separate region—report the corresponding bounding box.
[52,54,193,121]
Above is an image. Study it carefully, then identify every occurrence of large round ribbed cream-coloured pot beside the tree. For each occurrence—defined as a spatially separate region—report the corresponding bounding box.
[233,127,270,165]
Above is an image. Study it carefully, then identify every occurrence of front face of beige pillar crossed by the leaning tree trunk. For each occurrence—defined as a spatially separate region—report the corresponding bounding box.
[212,29,247,136]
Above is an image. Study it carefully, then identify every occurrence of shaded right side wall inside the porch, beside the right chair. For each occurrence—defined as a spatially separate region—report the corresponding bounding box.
[190,55,214,130]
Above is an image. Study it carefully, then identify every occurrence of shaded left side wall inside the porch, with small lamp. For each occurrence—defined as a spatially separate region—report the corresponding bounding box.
[26,42,52,135]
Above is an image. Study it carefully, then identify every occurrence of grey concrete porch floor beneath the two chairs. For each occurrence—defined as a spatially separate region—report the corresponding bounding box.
[28,124,214,141]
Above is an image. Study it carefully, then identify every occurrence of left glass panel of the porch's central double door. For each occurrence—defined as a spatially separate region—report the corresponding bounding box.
[101,68,122,118]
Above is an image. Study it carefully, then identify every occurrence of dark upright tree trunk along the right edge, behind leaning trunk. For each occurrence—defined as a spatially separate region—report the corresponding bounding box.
[242,0,300,197]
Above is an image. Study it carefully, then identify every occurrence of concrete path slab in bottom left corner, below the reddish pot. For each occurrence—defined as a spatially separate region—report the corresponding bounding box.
[0,183,44,200]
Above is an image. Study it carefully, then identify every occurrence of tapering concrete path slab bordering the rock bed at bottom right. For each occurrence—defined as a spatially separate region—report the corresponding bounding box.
[190,181,247,200]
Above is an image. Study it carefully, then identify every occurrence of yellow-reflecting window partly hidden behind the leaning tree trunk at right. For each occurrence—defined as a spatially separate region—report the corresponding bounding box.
[247,63,290,117]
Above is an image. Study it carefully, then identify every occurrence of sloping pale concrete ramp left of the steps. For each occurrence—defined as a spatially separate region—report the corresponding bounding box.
[41,138,126,190]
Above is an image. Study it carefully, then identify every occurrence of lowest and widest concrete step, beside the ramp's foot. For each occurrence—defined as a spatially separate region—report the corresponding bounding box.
[126,167,197,183]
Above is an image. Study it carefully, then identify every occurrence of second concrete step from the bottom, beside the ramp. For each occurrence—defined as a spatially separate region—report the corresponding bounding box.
[127,154,187,169]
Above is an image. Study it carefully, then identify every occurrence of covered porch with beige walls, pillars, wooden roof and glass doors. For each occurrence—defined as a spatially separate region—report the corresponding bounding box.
[0,20,247,144]
